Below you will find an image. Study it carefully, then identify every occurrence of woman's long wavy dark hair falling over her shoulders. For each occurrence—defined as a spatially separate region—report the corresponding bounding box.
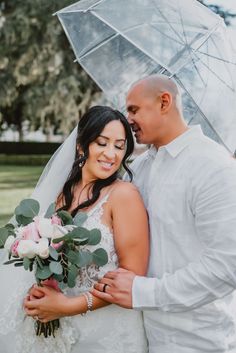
[59,106,134,217]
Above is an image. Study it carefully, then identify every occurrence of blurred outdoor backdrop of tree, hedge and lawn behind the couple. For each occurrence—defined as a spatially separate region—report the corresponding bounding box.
[0,0,236,226]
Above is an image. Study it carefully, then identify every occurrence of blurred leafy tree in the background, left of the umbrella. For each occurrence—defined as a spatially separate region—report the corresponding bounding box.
[0,0,99,139]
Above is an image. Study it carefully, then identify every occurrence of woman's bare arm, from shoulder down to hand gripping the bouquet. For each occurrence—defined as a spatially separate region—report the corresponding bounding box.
[24,182,149,322]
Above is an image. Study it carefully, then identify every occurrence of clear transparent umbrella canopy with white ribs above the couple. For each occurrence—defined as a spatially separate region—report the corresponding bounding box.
[57,0,236,152]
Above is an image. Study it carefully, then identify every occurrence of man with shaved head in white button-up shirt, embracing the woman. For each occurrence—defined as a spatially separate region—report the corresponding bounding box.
[93,75,236,353]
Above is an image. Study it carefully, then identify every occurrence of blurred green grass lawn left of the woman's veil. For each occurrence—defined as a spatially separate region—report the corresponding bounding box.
[0,165,43,227]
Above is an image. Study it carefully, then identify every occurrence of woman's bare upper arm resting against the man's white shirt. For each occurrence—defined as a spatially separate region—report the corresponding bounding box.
[110,182,149,276]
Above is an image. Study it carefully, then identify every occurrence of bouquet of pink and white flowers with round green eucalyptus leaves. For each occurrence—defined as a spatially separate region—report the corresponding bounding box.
[0,199,108,337]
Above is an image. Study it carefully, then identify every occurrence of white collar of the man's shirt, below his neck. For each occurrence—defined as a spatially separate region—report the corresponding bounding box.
[163,125,203,158]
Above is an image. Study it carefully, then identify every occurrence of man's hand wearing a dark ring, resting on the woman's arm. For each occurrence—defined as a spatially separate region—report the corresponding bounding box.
[91,268,136,308]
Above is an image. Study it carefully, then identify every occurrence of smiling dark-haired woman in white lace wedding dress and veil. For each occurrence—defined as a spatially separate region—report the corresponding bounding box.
[0,106,149,353]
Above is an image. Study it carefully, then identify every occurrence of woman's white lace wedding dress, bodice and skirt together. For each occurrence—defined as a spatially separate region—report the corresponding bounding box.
[0,195,147,353]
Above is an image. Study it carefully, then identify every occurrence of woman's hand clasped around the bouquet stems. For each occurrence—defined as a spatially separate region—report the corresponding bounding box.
[24,286,69,322]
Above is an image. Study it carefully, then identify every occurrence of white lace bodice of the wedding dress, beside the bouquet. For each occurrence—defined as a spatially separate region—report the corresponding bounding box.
[66,194,118,295]
